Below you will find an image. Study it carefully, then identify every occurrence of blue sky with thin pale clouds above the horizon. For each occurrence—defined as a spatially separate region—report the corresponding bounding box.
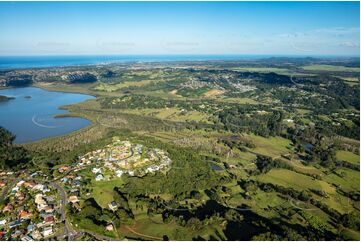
[0,2,360,56]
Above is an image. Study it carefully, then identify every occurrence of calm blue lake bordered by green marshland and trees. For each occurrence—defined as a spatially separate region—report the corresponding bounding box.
[0,87,94,143]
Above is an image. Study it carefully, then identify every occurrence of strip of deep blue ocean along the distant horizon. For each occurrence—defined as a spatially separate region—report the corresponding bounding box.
[0,55,270,69]
